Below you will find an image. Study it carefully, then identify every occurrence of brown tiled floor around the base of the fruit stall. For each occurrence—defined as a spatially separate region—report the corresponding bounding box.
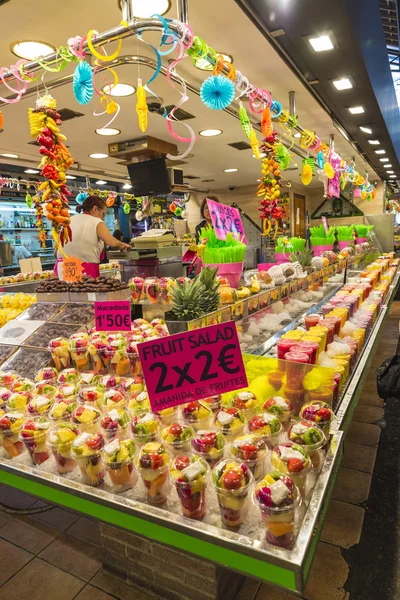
[0,302,400,600]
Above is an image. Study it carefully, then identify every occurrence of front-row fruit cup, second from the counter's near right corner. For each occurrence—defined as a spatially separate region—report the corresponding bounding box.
[212,459,253,527]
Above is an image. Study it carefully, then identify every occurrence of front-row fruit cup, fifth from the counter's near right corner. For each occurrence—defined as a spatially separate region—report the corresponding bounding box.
[102,438,137,492]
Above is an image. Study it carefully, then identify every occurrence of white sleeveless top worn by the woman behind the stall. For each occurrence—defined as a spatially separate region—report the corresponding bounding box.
[57,214,104,264]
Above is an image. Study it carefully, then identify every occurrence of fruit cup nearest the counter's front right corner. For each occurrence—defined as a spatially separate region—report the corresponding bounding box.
[254,471,299,548]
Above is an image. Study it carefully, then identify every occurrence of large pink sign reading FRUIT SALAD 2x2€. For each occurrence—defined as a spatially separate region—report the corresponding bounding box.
[137,321,247,412]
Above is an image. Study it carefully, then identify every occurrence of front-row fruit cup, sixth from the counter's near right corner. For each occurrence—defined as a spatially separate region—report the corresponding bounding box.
[72,431,106,486]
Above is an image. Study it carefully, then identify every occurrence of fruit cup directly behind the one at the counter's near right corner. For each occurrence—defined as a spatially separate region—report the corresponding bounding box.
[270,442,312,496]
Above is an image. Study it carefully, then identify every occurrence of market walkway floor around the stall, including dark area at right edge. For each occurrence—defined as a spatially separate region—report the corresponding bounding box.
[0,302,400,600]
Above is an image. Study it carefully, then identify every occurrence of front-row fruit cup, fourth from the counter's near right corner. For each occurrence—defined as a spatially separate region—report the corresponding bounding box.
[137,442,170,504]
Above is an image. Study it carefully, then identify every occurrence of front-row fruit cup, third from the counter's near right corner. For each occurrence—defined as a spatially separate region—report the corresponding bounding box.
[170,454,208,519]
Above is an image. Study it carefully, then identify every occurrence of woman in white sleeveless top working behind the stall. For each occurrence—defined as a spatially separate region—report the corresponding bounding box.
[54,196,131,279]
